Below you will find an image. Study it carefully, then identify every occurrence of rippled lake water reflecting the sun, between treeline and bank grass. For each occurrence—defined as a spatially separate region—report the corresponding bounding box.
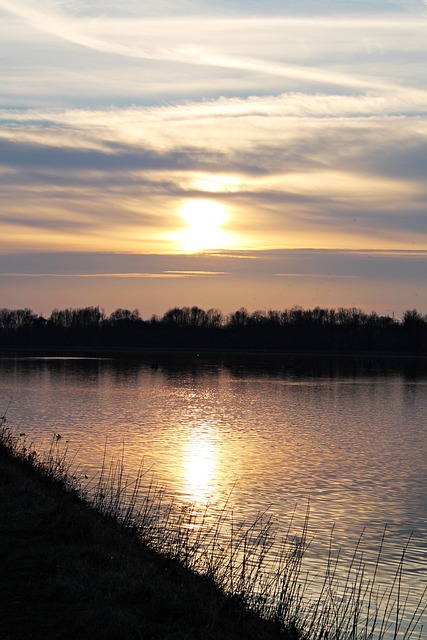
[0,357,427,626]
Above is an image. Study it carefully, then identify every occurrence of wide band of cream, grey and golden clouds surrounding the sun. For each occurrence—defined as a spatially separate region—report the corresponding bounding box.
[0,95,427,251]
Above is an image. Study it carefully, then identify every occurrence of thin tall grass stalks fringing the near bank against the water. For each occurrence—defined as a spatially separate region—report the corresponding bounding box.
[0,416,427,640]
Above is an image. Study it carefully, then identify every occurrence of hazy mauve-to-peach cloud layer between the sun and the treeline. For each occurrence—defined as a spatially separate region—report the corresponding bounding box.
[0,249,427,317]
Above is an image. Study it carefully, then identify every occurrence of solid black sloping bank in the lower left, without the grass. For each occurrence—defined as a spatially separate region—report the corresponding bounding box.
[0,449,288,640]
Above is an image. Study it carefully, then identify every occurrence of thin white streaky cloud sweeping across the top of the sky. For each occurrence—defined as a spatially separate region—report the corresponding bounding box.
[0,0,426,104]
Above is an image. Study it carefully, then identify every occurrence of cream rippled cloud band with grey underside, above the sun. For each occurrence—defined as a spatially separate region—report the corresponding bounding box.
[0,95,427,178]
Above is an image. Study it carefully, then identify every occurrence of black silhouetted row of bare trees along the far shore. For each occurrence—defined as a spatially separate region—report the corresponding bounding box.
[0,306,427,355]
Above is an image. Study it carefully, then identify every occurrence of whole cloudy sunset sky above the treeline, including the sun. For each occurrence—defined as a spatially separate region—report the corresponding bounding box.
[0,0,427,318]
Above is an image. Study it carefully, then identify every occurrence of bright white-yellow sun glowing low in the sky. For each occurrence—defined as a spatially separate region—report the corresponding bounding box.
[177,199,230,252]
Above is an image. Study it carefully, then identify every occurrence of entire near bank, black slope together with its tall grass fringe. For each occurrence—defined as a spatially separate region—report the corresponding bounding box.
[0,416,426,640]
